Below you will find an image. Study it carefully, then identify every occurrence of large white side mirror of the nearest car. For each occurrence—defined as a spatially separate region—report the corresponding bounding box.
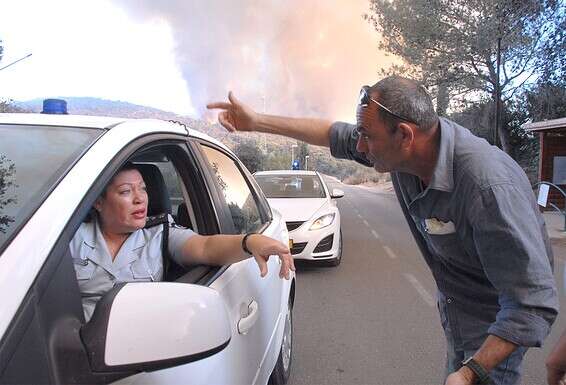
[81,282,231,372]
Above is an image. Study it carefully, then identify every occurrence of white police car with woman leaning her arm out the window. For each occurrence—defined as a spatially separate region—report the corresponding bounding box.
[0,109,295,384]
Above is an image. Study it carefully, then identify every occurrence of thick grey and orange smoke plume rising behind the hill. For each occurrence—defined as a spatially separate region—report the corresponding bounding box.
[115,0,393,120]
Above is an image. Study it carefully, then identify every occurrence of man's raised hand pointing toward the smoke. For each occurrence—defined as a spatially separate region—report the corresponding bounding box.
[206,91,257,132]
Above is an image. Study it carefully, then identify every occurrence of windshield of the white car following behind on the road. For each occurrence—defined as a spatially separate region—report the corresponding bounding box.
[255,174,326,198]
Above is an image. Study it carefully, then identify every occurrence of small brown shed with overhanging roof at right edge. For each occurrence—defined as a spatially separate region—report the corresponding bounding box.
[523,118,566,209]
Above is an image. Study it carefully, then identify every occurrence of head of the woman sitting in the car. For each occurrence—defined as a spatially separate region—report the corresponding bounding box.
[94,170,147,234]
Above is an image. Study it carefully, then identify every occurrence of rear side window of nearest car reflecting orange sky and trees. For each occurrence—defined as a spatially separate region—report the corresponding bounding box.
[202,146,264,234]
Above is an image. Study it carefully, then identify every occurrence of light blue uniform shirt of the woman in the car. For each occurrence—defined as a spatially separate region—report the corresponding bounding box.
[69,220,195,322]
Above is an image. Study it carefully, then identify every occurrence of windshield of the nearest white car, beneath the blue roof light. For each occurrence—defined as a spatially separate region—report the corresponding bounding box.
[0,124,103,252]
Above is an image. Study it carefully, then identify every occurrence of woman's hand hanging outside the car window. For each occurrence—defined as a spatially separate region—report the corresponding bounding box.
[246,234,295,279]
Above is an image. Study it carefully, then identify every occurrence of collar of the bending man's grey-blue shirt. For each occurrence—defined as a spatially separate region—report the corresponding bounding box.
[428,118,460,192]
